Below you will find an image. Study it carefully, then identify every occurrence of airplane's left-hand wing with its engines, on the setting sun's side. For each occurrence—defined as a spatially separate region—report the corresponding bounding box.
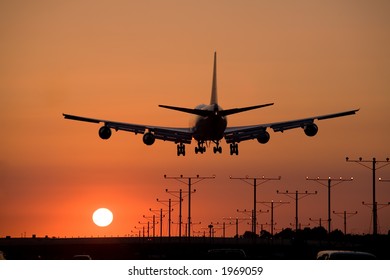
[63,114,192,145]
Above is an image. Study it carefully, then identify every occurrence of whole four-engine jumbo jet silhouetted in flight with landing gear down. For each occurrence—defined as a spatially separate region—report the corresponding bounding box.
[63,52,359,156]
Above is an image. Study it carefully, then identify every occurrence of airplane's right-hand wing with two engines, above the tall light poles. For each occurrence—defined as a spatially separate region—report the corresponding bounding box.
[224,109,359,144]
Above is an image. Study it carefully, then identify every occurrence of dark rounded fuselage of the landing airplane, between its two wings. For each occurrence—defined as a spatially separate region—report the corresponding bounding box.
[193,104,227,141]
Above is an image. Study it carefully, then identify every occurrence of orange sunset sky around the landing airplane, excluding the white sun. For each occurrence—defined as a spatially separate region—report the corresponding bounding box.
[0,0,390,236]
